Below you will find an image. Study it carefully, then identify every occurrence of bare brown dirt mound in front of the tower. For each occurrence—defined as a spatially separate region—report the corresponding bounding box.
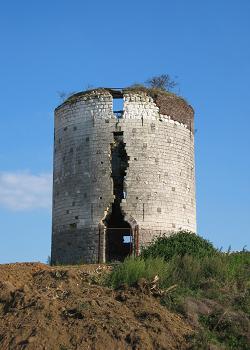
[0,263,192,350]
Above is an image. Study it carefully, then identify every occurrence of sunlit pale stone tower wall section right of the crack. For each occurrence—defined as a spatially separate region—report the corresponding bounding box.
[119,95,196,245]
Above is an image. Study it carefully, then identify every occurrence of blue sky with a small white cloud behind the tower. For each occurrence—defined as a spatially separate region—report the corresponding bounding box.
[0,0,250,263]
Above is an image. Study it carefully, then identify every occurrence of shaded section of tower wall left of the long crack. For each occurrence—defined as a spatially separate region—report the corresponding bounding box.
[52,92,116,263]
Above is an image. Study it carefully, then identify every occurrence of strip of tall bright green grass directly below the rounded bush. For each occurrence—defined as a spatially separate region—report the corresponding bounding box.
[107,252,250,298]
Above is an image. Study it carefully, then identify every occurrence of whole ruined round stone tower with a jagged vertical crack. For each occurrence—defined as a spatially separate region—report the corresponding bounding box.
[51,87,196,264]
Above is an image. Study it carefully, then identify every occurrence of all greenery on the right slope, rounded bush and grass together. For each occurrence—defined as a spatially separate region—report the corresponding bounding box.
[106,231,250,350]
